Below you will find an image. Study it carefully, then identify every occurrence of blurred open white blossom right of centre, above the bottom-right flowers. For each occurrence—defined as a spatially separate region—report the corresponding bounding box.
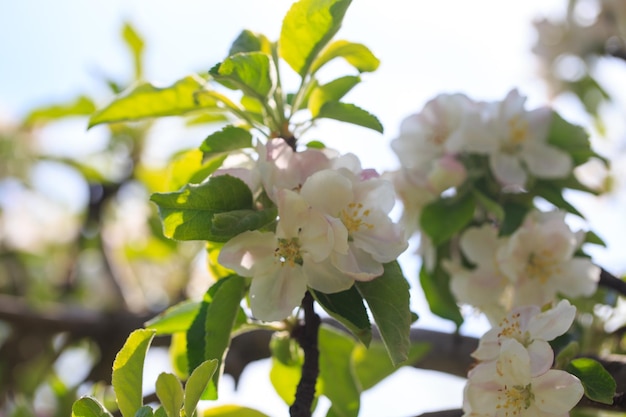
[497,211,600,307]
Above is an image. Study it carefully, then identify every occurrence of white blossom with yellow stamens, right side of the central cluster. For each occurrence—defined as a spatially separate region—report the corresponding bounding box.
[301,169,408,280]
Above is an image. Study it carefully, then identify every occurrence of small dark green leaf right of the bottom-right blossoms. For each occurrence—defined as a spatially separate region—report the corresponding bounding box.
[566,358,617,404]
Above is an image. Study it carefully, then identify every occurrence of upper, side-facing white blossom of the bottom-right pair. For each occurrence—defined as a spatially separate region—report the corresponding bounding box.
[472,300,576,375]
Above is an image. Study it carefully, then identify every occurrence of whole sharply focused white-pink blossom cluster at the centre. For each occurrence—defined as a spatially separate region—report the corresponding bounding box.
[218,139,408,321]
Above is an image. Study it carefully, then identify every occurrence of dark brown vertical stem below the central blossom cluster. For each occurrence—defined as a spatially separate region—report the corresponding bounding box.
[289,291,320,417]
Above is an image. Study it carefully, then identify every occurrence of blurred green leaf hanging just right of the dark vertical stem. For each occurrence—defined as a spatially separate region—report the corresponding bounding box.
[319,325,361,417]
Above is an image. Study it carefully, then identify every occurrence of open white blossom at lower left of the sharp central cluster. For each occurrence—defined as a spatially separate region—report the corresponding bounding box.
[218,189,353,321]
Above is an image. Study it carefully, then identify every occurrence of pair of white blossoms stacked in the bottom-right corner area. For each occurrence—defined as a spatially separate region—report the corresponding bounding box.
[463,300,584,417]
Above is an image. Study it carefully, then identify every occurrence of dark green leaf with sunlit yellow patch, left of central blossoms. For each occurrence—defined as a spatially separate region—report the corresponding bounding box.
[150,175,252,240]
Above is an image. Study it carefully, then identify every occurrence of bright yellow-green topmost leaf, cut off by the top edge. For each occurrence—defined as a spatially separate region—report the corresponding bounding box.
[278,0,350,77]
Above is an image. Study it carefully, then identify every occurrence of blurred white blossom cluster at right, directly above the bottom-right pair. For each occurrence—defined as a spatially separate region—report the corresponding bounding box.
[444,211,600,322]
